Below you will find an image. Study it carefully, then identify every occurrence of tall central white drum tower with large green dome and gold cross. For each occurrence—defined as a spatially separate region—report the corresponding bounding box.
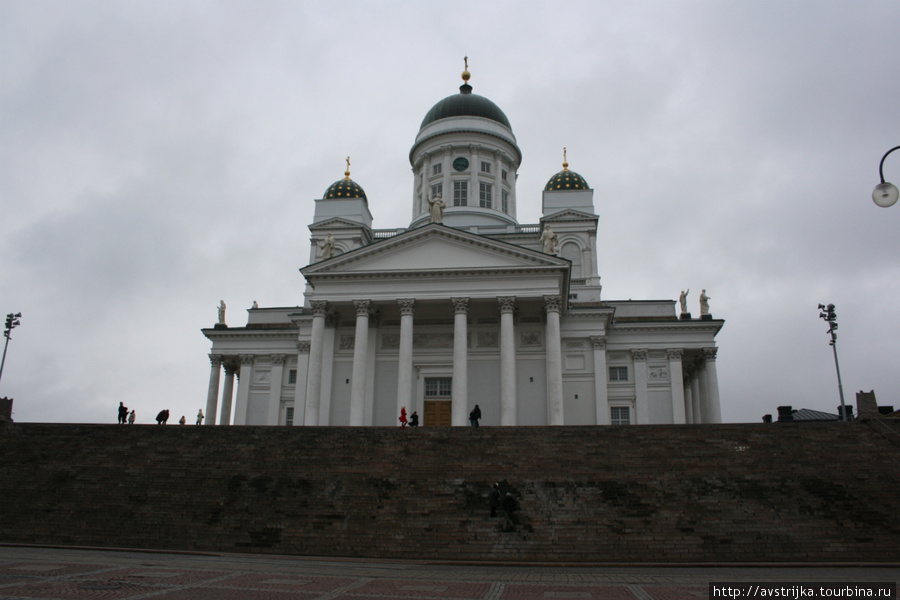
[409,59,522,228]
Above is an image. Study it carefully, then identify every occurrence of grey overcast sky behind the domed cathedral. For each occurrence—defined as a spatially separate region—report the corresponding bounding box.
[0,0,900,423]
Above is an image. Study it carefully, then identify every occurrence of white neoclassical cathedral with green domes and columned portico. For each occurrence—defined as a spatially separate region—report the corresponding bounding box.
[203,63,724,427]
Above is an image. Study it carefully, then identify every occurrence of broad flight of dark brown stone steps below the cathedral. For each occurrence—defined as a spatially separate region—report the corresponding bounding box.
[0,422,900,563]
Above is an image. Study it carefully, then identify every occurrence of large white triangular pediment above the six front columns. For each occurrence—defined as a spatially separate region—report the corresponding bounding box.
[301,224,568,278]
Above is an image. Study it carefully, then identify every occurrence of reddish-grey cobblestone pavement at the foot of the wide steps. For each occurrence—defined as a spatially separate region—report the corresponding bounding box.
[0,546,900,600]
